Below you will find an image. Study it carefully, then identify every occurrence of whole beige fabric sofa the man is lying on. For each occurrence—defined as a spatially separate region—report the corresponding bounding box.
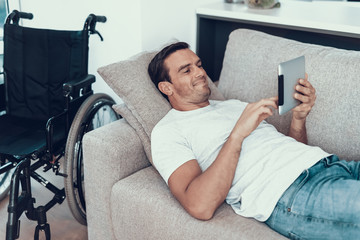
[83,29,360,240]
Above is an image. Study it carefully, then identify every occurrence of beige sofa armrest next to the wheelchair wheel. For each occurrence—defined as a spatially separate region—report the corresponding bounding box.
[83,119,150,239]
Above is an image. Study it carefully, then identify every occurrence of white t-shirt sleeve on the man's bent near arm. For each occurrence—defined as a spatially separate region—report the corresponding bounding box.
[151,126,195,184]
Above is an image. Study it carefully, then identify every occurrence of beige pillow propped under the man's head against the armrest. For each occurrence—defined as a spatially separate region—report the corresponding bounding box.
[98,46,224,162]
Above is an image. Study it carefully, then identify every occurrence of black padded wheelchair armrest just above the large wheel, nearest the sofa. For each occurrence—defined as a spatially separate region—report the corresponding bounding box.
[63,74,95,97]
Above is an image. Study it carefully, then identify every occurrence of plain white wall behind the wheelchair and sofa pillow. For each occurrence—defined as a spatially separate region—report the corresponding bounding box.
[9,0,217,102]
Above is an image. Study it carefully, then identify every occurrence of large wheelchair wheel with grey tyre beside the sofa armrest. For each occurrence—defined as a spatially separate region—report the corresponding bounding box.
[64,94,120,225]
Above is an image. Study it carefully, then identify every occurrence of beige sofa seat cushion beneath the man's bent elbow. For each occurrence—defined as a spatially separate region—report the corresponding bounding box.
[111,167,286,240]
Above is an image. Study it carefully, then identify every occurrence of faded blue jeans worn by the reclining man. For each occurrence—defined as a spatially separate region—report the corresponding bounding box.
[266,156,360,240]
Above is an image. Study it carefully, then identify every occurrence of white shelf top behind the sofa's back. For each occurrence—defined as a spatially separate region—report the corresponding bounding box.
[196,1,360,38]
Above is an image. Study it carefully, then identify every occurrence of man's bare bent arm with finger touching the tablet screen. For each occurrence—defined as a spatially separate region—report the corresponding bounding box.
[168,98,277,220]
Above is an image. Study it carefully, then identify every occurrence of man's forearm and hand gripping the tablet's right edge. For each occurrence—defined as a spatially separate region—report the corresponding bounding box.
[288,74,316,144]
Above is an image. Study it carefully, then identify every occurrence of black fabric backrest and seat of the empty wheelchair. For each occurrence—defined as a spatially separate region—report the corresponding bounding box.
[0,24,88,156]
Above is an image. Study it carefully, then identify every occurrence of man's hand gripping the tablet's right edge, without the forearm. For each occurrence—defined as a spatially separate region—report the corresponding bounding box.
[292,73,316,120]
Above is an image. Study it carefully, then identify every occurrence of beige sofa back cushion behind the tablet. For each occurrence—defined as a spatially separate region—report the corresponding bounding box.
[219,29,360,160]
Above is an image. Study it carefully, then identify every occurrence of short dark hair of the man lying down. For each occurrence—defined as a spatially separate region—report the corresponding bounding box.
[148,42,189,100]
